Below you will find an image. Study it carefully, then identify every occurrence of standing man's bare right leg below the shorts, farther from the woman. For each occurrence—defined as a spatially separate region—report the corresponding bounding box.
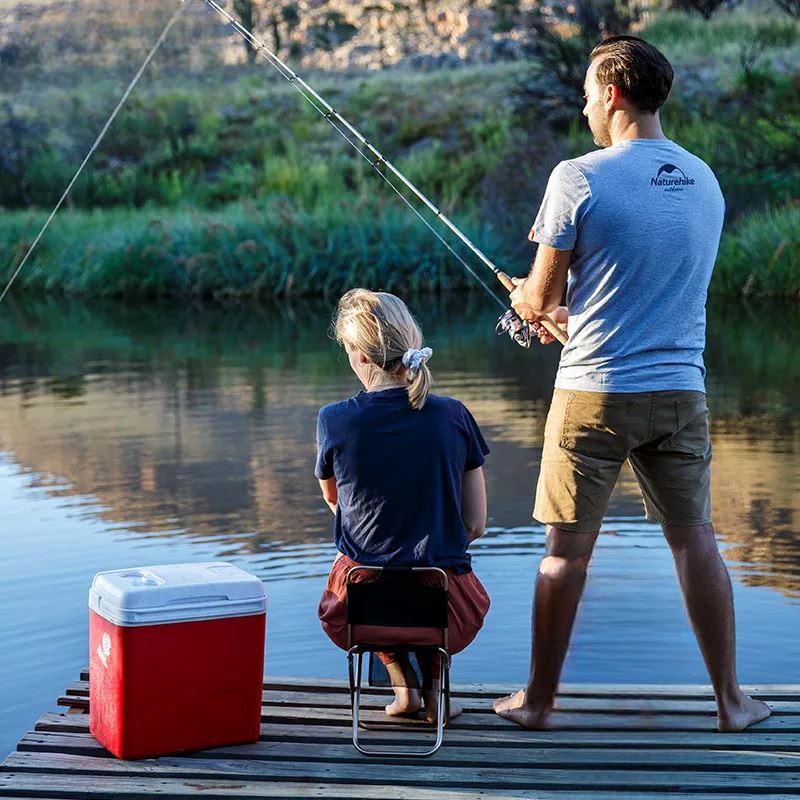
[663,524,770,731]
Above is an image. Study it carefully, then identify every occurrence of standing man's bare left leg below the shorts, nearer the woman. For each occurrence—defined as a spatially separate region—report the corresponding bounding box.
[494,526,598,728]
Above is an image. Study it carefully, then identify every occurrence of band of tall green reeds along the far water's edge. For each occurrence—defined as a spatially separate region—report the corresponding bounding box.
[0,201,800,299]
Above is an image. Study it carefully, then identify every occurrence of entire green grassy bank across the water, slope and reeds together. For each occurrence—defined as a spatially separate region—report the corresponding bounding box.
[0,5,800,297]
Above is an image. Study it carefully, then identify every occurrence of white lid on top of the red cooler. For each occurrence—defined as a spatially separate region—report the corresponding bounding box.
[89,561,267,626]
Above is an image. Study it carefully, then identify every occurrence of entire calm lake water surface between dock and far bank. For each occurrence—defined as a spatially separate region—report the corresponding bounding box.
[0,296,800,755]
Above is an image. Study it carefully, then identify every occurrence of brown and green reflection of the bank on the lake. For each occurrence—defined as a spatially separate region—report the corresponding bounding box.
[0,296,800,596]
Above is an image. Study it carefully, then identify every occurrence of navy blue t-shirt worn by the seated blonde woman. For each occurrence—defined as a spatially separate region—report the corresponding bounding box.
[314,387,489,573]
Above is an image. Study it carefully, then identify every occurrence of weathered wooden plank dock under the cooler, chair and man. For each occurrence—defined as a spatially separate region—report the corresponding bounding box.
[0,674,800,800]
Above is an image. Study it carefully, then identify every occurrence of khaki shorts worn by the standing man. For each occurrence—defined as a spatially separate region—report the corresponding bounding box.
[533,389,711,531]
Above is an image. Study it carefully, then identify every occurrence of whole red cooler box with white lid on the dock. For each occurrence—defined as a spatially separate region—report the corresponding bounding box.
[89,563,267,758]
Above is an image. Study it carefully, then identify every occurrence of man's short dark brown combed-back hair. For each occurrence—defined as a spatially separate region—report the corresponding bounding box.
[591,36,673,114]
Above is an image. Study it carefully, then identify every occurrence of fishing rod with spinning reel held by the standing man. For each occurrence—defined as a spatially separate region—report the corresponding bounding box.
[191,0,567,347]
